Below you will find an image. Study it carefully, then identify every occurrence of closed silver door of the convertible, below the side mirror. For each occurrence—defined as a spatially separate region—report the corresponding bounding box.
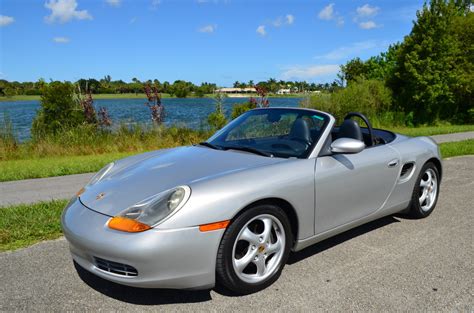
[315,145,400,234]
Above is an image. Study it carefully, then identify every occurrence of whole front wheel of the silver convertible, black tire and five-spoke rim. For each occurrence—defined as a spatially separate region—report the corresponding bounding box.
[216,205,292,294]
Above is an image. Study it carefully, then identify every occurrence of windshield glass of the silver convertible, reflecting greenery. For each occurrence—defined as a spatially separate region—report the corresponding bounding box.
[207,108,329,158]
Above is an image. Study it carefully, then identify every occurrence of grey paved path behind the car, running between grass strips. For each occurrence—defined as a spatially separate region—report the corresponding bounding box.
[0,131,474,207]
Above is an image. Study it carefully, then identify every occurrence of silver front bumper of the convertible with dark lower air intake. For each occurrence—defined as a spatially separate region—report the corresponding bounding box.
[61,199,224,289]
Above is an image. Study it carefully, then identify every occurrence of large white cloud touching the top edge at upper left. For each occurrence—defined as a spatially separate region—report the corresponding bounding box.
[44,0,92,23]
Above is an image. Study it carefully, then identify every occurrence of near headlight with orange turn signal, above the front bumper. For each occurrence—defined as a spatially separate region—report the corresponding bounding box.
[108,186,191,232]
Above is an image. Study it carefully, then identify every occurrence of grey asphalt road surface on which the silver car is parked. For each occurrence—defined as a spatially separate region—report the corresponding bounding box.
[0,156,474,312]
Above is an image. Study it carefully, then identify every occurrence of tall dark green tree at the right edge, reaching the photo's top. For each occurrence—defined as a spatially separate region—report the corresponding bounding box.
[389,0,473,124]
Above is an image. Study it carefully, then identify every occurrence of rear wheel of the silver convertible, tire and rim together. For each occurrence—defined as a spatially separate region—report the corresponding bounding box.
[409,162,440,218]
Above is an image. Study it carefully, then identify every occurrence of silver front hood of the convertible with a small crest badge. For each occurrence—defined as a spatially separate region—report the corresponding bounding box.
[80,146,285,216]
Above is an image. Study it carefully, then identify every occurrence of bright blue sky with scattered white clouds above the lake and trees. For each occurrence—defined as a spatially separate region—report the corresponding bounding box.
[0,0,423,86]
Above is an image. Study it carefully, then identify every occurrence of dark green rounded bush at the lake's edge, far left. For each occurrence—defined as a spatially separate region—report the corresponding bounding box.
[31,81,85,138]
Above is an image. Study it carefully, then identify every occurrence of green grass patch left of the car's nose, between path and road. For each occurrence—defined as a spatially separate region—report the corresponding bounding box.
[0,200,67,252]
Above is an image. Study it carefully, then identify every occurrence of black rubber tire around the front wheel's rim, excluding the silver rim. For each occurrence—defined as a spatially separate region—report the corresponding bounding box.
[216,205,293,294]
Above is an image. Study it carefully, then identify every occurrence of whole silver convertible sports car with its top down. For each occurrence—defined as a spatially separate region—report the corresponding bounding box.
[62,108,442,294]
